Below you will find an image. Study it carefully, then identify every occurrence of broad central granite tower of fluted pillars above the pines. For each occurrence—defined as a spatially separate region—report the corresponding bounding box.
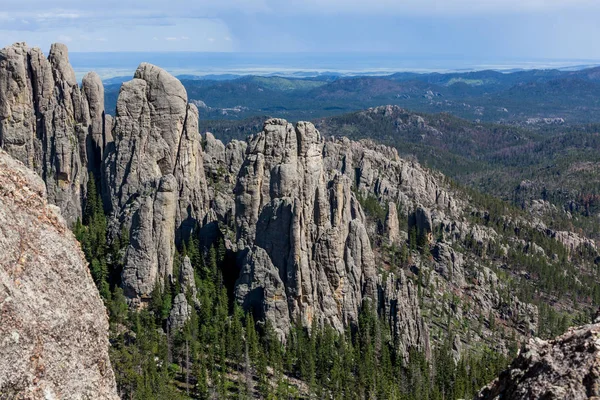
[235,119,376,334]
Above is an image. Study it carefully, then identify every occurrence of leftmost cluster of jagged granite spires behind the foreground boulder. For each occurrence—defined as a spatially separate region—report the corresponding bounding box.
[0,43,110,224]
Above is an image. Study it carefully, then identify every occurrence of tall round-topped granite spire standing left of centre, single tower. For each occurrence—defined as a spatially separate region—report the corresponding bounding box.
[104,63,208,300]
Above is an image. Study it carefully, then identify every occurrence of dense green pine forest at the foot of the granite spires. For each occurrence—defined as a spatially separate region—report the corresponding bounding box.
[74,175,517,400]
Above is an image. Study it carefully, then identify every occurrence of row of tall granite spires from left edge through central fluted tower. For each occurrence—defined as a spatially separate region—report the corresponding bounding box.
[0,44,436,356]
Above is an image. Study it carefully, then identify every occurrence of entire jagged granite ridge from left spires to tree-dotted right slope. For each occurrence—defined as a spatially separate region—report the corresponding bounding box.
[0,45,584,370]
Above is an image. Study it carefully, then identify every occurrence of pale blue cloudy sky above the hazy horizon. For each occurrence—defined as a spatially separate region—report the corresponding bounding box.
[0,0,600,59]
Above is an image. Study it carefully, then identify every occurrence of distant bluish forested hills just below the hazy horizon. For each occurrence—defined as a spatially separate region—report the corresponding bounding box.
[106,67,600,124]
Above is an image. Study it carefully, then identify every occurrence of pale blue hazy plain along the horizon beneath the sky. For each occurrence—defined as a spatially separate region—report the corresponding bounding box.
[61,50,600,79]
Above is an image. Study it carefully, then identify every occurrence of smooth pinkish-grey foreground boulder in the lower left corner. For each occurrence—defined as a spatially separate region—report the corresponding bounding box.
[0,149,118,399]
